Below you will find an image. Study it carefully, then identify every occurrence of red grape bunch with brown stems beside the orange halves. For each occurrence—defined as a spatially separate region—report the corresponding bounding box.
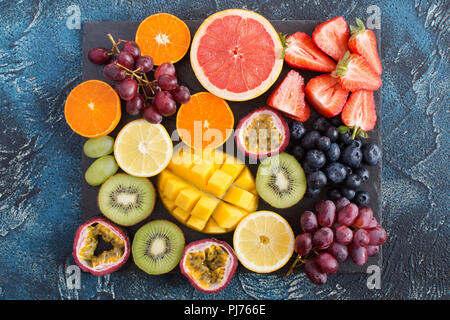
[88,34,191,123]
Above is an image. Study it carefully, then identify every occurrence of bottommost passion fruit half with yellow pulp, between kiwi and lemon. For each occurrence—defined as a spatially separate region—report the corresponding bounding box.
[180,238,238,293]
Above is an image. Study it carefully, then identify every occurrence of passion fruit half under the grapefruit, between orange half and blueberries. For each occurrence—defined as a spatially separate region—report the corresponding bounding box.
[235,107,290,159]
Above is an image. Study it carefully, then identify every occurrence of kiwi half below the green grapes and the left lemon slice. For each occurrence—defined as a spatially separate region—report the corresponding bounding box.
[98,173,156,226]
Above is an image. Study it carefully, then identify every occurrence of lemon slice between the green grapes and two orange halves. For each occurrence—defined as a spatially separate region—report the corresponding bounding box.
[114,119,173,177]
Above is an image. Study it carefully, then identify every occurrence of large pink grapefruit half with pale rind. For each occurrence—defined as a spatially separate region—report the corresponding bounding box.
[190,9,284,101]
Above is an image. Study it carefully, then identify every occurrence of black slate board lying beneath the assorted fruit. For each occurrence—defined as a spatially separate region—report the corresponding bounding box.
[81,20,382,274]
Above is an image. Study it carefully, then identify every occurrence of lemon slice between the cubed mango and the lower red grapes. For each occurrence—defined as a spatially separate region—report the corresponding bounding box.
[233,211,294,273]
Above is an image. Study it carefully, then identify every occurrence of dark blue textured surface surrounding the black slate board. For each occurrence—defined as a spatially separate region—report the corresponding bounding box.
[0,0,450,299]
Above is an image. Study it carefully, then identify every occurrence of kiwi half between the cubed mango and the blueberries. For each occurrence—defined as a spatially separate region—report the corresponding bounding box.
[256,152,306,208]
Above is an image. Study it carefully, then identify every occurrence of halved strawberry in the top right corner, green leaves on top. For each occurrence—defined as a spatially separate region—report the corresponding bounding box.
[348,19,383,75]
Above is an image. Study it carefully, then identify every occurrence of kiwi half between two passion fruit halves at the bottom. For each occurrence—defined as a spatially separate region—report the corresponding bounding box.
[131,220,185,275]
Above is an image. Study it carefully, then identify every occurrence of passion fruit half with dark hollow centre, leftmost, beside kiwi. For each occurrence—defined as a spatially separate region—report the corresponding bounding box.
[72,217,130,276]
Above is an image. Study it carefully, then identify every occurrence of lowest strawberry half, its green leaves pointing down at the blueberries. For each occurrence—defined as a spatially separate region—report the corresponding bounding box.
[339,90,377,138]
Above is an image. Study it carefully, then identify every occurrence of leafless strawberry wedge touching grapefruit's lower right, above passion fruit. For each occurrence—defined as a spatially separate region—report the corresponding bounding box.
[267,70,311,122]
